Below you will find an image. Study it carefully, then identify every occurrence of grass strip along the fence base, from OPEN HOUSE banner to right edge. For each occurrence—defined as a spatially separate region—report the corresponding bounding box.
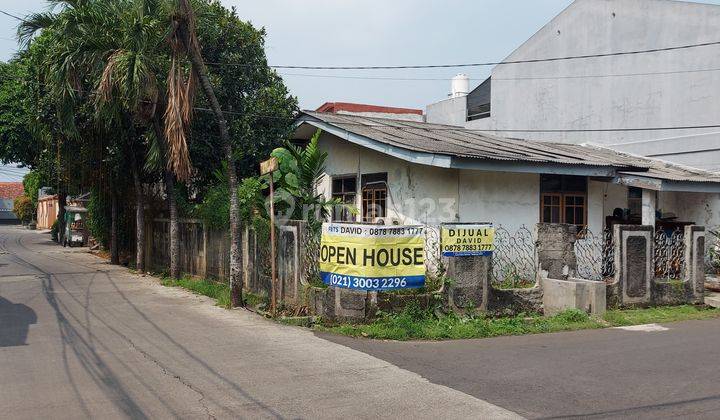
[315,305,720,340]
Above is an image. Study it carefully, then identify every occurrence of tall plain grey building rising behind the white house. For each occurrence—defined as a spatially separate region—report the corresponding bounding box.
[427,0,720,171]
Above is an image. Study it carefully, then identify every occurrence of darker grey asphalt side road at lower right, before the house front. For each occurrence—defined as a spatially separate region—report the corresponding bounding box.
[321,310,720,419]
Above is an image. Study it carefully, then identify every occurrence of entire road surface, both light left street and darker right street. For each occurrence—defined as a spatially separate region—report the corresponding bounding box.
[0,226,720,419]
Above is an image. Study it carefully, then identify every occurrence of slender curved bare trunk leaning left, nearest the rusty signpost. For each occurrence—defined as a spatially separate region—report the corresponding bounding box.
[181,28,244,307]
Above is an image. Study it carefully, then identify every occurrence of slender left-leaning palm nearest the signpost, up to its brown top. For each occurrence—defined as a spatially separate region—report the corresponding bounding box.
[168,0,244,307]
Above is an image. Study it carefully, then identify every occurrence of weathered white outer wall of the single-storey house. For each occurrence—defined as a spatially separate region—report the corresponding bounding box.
[319,133,616,232]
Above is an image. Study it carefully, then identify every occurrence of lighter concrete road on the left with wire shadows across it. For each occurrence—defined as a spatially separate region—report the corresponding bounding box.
[0,226,517,419]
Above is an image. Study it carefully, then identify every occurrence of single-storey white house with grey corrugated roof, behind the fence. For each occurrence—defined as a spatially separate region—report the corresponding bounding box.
[295,111,720,233]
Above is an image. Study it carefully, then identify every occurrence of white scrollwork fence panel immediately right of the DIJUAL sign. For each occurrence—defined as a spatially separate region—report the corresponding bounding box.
[492,225,537,288]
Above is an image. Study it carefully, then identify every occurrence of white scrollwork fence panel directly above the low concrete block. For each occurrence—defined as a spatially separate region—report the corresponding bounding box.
[575,228,615,281]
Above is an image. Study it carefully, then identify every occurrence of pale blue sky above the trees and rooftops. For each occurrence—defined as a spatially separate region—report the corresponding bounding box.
[0,0,720,109]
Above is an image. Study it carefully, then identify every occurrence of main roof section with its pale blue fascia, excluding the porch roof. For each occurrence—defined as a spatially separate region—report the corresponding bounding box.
[295,111,648,177]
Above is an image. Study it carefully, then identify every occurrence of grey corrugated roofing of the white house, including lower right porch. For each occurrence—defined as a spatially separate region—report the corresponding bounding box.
[300,111,720,182]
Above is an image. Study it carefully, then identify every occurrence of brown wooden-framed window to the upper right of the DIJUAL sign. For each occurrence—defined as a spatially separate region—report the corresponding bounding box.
[540,175,587,228]
